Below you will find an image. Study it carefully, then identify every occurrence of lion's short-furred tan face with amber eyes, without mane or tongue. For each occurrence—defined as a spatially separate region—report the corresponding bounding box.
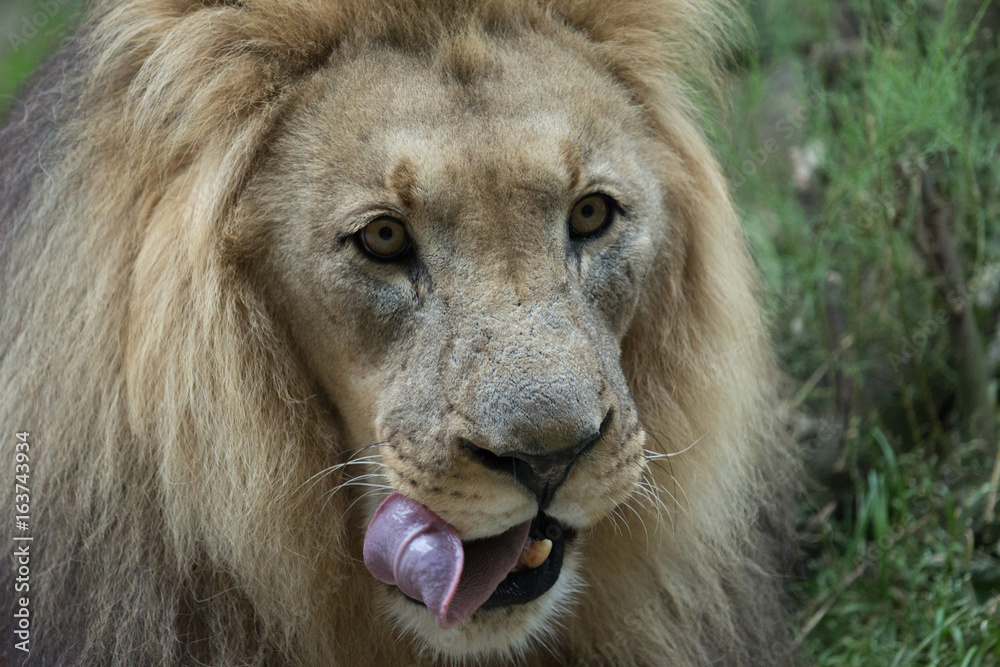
[249,34,667,653]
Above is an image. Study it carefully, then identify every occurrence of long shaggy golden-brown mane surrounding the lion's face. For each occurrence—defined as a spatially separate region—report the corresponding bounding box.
[0,0,794,665]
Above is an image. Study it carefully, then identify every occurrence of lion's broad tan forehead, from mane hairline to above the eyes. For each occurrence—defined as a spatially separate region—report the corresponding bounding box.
[301,36,644,199]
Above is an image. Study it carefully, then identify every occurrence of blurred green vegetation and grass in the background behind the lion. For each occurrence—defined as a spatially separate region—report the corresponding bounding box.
[0,0,1000,667]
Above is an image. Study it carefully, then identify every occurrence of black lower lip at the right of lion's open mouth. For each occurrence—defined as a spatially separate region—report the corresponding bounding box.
[405,512,576,609]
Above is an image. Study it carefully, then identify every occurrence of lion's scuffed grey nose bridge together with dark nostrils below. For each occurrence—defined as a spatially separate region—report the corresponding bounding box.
[426,298,631,510]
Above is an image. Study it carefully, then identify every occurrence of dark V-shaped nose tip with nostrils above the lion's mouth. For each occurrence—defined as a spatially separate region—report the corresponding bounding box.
[460,410,611,510]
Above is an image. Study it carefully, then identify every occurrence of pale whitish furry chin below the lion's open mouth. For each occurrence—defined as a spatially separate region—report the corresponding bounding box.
[386,547,584,658]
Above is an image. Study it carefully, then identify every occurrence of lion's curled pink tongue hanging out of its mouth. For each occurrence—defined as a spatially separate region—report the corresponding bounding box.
[364,493,531,628]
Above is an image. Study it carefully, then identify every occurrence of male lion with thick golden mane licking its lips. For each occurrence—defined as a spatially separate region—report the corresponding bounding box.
[0,0,794,666]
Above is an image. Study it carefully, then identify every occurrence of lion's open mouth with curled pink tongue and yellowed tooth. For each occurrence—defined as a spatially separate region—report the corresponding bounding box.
[364,493,572,628]
